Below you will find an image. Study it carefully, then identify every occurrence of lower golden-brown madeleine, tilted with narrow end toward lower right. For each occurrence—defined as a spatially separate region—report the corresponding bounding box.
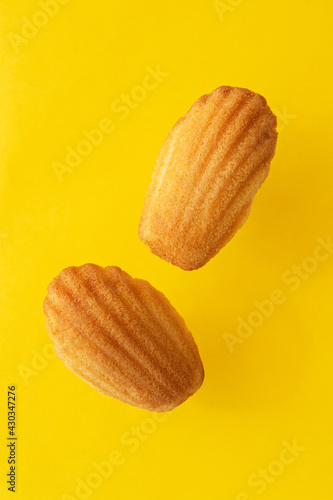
[43,264,204,411]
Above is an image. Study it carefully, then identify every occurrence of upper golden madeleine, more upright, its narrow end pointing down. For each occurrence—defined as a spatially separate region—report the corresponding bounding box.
[139,87,277,270]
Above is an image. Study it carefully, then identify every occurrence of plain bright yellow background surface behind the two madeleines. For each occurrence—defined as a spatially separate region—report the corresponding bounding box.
[0,0,333,500]
